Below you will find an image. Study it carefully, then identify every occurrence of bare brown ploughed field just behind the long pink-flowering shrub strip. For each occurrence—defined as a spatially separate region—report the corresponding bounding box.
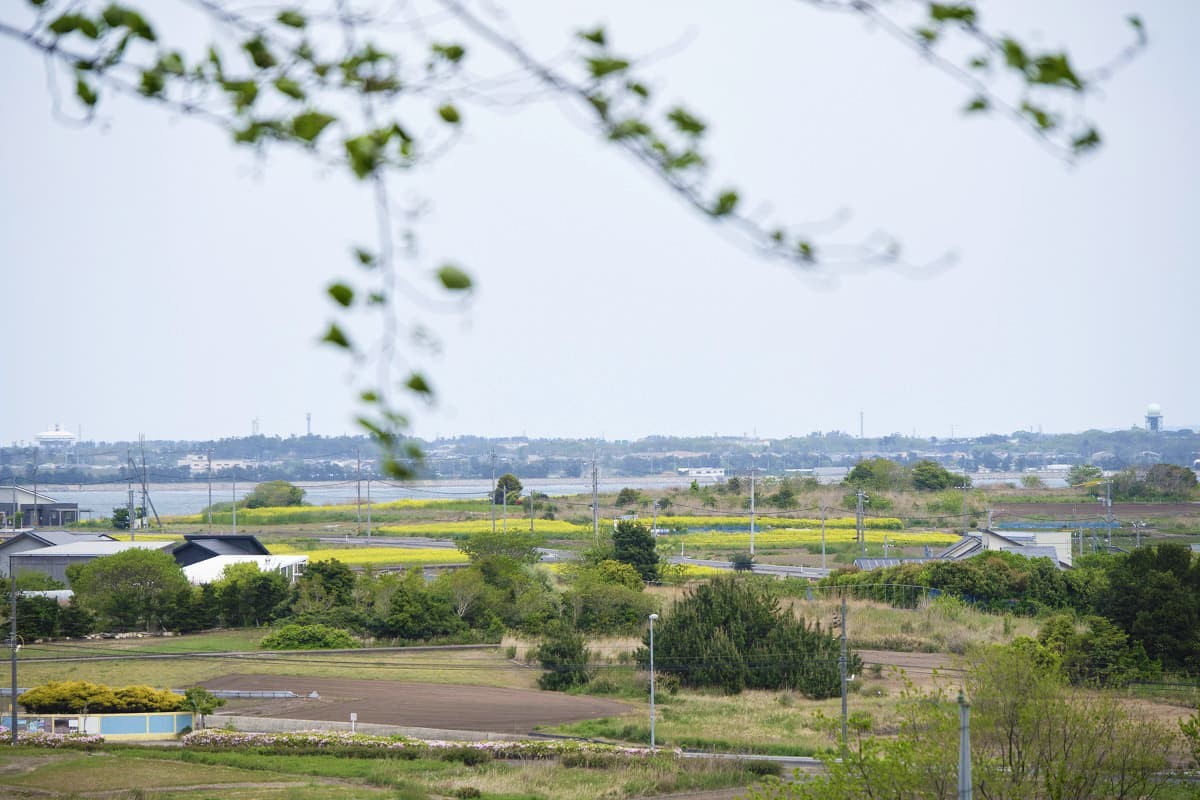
[204,675,630,733]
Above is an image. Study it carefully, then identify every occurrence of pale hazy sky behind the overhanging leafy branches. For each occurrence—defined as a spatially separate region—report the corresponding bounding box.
[0,0,1200,444]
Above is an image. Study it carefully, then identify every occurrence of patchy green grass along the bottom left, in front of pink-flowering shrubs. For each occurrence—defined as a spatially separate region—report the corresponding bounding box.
[0,745,761,800]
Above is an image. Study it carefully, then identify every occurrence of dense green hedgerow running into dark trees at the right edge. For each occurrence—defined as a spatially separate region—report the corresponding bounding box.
[821,543,1200,674]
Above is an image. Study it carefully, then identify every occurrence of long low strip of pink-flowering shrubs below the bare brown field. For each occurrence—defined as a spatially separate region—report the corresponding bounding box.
[182,728,679,763]
